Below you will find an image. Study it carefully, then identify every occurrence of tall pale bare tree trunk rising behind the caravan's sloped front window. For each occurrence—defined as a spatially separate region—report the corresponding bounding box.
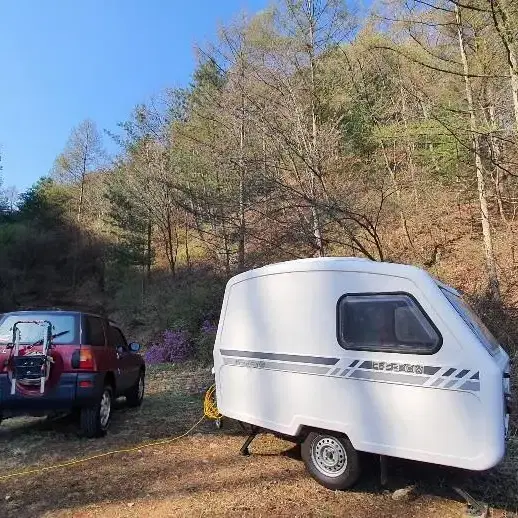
[455,4,500,302]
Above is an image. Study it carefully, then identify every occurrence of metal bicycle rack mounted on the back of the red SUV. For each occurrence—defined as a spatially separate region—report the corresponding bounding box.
[11,320,53,395]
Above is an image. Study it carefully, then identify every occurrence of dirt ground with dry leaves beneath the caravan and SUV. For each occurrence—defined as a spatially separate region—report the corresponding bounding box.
[0,367,518,518]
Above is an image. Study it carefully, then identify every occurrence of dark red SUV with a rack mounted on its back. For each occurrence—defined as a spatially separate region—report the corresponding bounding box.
[0,311,146,437]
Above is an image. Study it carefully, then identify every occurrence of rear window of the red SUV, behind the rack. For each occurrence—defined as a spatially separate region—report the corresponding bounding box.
[0,313,78,345]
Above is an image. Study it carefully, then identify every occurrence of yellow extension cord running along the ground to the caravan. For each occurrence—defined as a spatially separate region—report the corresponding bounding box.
[0,385,222,480]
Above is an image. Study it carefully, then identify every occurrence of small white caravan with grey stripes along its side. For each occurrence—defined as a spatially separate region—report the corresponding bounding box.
[214,258,509,489]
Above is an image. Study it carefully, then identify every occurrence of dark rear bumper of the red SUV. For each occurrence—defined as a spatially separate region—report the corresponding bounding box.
[0,372,103,414]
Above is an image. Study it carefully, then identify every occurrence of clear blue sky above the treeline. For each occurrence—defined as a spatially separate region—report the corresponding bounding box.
[0,0,267,190]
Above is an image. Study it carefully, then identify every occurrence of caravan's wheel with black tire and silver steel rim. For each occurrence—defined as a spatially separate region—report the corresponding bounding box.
[301,431,360,490]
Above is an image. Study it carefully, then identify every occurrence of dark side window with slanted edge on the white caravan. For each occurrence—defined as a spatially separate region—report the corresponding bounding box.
[337,293,442,354]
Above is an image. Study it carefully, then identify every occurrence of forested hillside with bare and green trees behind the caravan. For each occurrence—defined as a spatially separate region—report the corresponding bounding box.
[0,0,518,357]
